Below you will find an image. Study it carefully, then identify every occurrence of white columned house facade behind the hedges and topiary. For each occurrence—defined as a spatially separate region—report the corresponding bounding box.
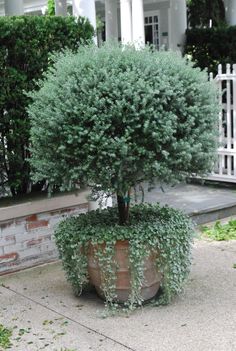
[0,0,236,50]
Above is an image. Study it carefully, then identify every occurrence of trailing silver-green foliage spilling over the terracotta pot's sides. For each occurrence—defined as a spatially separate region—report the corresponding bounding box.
[55,204,193,309]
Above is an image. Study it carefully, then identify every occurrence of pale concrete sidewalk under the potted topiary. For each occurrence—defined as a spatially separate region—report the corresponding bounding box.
[0,240,236,351]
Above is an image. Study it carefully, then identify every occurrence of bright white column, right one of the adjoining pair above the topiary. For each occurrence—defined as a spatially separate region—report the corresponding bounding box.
[132,0,145,47]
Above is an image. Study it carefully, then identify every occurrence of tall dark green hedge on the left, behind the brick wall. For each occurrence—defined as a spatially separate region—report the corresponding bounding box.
[0,16,93,195]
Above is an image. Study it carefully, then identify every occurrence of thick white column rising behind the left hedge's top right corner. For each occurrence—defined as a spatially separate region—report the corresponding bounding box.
[72,0,96,29]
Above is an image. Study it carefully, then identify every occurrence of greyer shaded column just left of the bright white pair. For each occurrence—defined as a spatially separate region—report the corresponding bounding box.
[105,0,118,40]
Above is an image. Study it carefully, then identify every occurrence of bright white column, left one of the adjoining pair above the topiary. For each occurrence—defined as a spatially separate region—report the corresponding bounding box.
[120,0,132,44]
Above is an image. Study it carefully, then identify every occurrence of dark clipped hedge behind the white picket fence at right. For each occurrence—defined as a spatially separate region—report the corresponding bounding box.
[185,26,236,73]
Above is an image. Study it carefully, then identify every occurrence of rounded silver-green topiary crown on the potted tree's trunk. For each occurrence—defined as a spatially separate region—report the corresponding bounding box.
[28,45,217,196]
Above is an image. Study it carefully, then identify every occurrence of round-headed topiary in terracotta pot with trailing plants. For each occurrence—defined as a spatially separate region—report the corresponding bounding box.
[28,44,217,308]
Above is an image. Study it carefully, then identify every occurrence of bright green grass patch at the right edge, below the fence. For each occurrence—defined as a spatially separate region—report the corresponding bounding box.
[202,219,236,241]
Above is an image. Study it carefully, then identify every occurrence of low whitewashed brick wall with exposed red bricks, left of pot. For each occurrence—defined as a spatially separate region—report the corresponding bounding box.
[0,203,88,275]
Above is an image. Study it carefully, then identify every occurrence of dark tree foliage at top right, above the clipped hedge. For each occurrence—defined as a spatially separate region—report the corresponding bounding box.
[187,0,226,28]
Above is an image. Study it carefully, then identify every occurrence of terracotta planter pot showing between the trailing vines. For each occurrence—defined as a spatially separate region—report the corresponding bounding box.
[88,241,162,302]
